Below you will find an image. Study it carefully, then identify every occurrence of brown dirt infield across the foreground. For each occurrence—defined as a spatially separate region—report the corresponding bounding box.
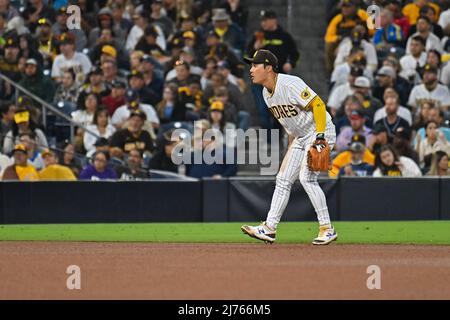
[0,242,450,299]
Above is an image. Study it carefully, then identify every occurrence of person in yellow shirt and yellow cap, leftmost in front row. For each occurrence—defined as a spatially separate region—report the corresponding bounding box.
[2,143,39,181]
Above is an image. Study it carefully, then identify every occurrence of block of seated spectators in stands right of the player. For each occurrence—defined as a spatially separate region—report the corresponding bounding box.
[325,0,450,177]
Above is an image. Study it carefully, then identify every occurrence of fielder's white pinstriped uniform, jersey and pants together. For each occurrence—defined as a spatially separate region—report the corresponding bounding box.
[263,74,336,229]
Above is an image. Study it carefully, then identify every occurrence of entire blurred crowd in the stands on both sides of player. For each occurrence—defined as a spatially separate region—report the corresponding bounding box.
[0,0,450,180]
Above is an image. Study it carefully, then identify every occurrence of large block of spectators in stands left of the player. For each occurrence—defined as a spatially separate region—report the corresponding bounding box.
[0,0,251,180]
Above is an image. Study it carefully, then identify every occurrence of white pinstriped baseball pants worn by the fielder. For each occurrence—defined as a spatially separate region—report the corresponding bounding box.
[266,131,336,229]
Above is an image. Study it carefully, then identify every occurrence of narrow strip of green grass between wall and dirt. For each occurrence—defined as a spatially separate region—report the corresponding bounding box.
[0,221,450,244]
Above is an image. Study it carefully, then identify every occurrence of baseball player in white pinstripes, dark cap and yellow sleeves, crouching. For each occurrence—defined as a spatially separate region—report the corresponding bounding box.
[241,50,337,245]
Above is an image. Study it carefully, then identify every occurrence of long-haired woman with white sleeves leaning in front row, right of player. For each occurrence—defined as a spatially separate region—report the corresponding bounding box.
[373,145,422,177]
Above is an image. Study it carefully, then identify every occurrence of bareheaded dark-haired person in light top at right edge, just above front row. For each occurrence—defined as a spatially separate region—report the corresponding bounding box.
[416,121,450,168]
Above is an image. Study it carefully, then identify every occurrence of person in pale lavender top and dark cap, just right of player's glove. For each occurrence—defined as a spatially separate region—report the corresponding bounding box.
[336,110,372,151]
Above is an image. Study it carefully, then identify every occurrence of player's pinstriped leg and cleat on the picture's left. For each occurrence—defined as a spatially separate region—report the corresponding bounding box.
[241,140,302,243]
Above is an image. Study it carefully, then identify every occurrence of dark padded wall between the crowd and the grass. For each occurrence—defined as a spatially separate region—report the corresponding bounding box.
[0,177,450,224]
